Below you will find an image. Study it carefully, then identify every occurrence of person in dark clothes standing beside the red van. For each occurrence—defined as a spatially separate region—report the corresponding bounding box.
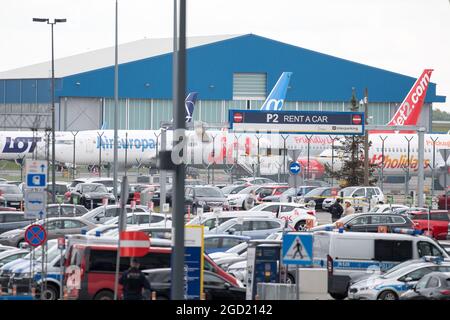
[119,258,151,300]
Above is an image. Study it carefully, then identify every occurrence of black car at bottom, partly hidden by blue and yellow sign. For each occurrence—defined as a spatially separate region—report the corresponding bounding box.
[143,268,245,300]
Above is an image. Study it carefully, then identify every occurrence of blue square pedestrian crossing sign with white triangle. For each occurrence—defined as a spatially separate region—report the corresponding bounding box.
[282,232,313,266]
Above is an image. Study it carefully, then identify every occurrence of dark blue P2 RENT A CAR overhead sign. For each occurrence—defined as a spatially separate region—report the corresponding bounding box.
[229,110,364,135]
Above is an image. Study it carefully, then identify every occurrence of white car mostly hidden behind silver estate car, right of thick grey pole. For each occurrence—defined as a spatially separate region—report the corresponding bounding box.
[186,211,274,231]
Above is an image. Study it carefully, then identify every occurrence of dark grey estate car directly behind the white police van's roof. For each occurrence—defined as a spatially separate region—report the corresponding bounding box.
[311,213,414,232]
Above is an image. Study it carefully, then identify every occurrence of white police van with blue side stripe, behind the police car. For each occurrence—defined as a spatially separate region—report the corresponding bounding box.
[313,231,450,299]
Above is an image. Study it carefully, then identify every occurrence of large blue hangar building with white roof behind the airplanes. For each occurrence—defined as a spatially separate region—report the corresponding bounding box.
[0,34,445,130]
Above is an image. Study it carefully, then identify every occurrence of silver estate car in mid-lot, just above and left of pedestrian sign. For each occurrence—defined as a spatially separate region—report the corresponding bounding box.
[209,217,284,239]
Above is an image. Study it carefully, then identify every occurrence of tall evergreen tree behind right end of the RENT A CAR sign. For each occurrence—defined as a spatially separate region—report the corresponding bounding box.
[325,88,378,187]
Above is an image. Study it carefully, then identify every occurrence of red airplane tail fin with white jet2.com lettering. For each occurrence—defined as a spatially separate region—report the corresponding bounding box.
[388,69,433,126]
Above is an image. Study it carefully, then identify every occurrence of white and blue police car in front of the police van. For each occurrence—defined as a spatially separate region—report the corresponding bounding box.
[348,256,450,300]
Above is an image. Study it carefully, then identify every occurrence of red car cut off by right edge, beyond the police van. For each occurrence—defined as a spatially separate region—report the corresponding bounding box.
[409,210,450,240]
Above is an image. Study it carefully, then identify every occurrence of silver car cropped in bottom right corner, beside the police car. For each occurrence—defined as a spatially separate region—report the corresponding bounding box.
[400,272,450,300]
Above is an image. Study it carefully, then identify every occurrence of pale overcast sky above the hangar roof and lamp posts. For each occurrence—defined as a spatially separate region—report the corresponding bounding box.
[0,0,450,111]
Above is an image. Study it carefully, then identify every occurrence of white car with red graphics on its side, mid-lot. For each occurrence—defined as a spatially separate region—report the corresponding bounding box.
[248,202,317,230]
